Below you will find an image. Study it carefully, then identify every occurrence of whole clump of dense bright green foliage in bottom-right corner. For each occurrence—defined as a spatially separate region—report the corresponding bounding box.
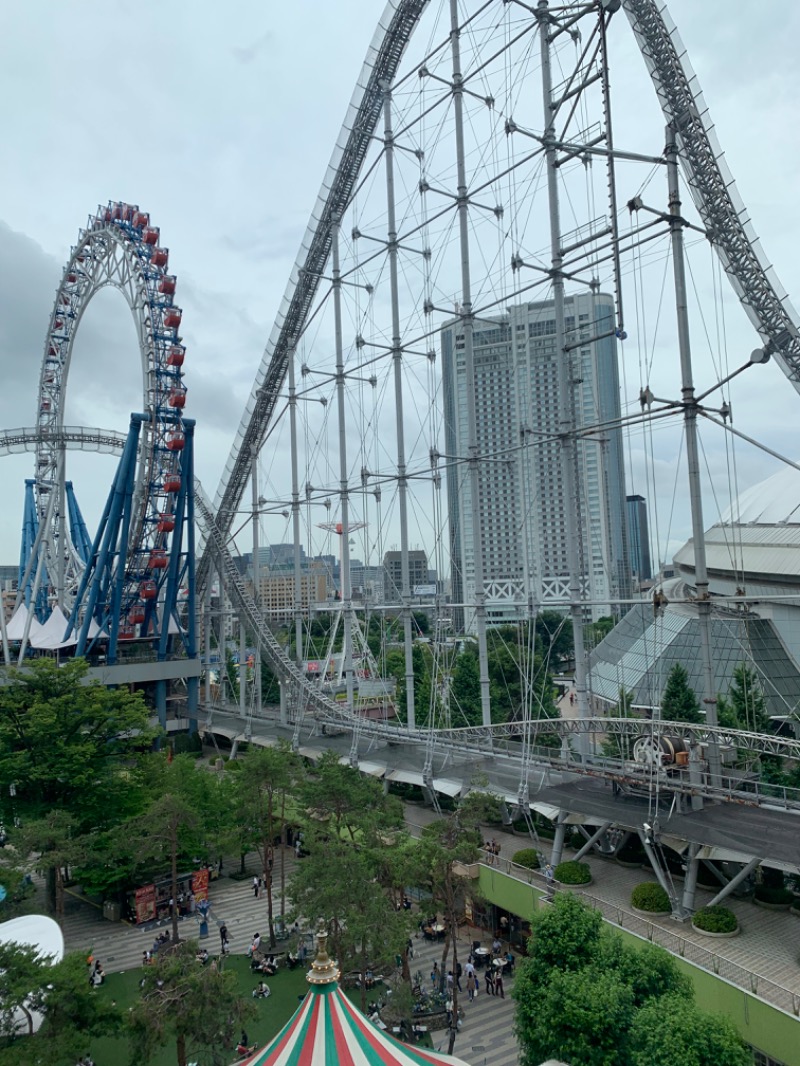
[513,893,749,1066]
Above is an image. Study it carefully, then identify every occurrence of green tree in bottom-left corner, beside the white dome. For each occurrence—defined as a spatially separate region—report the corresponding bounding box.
[0,942,122,1066]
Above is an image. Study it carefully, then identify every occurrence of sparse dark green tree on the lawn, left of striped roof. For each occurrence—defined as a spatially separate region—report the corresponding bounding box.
[128,940,255,1066]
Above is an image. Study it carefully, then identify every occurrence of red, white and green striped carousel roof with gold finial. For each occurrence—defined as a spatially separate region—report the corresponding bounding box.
[241,933,467,1066]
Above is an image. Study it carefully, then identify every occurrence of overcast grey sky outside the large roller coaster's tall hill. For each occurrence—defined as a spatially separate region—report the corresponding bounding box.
[0,0,800,563]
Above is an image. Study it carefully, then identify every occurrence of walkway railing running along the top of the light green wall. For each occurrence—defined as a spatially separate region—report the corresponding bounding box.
[488,859,800,1018]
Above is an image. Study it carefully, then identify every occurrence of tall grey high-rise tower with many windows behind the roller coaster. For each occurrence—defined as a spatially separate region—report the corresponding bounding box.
[442,293,630,632]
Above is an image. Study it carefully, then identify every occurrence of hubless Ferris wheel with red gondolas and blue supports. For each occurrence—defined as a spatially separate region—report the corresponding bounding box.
[19,201,193,651]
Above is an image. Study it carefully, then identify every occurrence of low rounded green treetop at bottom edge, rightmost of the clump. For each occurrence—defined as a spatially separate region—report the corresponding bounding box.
[626,996,753,1066]
